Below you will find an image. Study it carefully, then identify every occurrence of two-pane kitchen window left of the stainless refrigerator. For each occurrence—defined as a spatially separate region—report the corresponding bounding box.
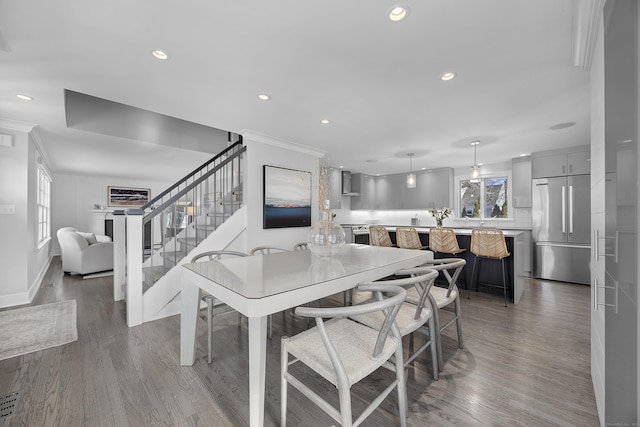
[460,176,509,219]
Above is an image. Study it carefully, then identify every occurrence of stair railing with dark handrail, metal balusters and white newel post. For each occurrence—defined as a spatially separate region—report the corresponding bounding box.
[121,141,246,326]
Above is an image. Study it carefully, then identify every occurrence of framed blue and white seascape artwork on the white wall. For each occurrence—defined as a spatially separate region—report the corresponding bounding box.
[263,165,311,228]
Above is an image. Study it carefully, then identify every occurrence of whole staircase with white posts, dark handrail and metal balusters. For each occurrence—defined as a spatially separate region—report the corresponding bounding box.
[114,140,246,326]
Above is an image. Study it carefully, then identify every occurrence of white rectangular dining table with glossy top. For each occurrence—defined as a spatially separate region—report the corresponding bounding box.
[180,244,431,427]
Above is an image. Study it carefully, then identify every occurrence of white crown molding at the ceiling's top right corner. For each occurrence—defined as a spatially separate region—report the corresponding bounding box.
[571,0,606,71]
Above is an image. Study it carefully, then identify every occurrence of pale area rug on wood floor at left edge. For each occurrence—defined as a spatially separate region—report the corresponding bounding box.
[0,300,78,360]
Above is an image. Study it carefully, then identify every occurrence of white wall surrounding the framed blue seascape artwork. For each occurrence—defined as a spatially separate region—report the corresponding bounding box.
[241,131,324,251]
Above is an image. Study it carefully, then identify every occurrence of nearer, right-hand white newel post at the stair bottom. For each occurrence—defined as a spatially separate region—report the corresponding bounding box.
[126,212,143,327]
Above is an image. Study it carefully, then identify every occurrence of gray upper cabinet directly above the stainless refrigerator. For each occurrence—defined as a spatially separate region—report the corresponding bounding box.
[532,145,591,178]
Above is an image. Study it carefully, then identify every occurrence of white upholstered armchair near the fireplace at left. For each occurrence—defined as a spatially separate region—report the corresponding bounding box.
[57,227,113,275]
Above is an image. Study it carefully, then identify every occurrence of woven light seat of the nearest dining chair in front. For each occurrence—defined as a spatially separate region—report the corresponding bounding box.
[287,319,399,387]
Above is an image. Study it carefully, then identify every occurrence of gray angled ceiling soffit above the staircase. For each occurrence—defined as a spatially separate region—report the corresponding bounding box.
[64,89,228,154]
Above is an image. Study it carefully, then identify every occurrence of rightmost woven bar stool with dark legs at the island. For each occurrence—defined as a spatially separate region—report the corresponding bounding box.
[467,228,511,307]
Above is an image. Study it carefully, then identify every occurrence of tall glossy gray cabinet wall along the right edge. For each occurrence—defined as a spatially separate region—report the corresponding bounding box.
[590,0,640,425]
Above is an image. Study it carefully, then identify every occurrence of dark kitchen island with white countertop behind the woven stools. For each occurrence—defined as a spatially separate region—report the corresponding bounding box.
[387,226,529,304]
